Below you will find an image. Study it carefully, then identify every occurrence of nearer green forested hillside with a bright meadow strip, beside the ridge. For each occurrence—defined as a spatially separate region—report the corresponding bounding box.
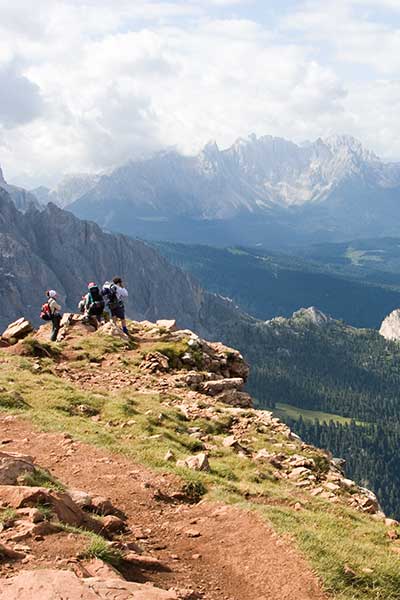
[214,309,400,517]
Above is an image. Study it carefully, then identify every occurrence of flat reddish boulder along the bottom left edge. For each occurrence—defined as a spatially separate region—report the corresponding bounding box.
[0,569,182,600]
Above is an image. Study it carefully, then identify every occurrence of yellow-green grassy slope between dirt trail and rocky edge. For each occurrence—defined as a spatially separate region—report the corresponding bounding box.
[0,341,400,600]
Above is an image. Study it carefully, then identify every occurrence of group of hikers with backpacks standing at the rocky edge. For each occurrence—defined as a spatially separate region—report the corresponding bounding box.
[40,277,129,342]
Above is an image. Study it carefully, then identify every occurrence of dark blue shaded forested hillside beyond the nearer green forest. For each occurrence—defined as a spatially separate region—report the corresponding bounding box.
[157,243,400,327]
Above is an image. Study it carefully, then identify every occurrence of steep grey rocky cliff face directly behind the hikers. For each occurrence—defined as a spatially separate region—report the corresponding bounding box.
[0,190,238,333]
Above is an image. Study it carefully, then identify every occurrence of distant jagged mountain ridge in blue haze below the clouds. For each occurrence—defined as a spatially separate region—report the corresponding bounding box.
[63,135,400,245]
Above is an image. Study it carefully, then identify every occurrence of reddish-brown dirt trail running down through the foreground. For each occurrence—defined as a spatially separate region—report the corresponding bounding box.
[0,417,326,600]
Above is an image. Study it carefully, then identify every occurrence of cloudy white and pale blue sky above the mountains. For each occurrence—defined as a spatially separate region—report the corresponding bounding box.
[0,0,400,188]
